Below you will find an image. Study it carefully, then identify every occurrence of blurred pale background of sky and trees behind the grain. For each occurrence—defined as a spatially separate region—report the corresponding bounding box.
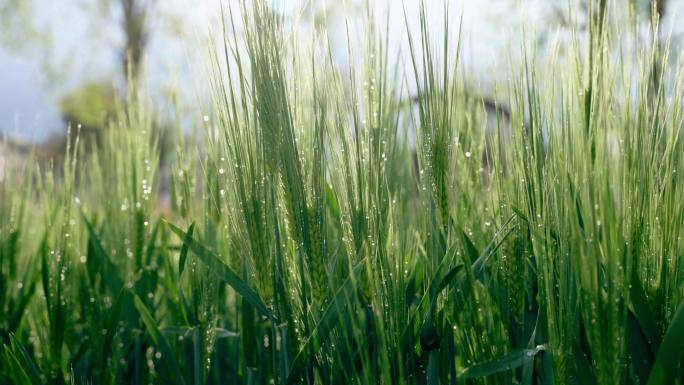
[0,0,684,157]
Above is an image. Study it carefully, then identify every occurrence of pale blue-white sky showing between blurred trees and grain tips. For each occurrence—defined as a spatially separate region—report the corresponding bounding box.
[0,0,682,140]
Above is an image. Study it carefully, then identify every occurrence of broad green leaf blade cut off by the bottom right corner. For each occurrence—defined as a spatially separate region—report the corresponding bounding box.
[648,301,684,385]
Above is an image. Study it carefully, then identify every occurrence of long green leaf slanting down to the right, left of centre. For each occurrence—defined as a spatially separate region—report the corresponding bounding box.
[166,222,277,321]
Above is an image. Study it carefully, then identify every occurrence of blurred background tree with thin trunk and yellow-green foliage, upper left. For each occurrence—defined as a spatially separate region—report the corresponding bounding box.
[0,0,162,154]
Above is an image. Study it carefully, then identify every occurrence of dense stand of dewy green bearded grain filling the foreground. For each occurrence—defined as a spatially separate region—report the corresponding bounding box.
[0,1,684,385]
